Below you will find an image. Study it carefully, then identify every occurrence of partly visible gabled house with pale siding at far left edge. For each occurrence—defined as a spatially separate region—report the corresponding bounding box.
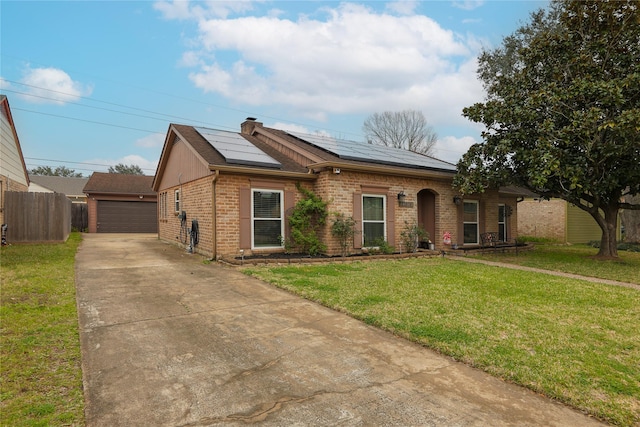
[0,95,29,224]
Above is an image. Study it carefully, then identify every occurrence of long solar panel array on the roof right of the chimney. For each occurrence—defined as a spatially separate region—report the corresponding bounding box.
[287,131,456,171]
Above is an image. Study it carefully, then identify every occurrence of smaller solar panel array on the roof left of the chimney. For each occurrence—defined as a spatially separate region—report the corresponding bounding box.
[194,127,282,168]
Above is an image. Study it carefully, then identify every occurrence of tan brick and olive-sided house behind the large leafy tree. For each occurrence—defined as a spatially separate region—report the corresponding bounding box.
[518,197,621,243]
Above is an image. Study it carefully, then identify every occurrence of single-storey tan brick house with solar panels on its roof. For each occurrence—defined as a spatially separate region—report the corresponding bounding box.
[153,118,517,259]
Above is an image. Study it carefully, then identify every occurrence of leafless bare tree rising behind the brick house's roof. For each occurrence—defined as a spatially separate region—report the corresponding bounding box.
[362,110,438,155]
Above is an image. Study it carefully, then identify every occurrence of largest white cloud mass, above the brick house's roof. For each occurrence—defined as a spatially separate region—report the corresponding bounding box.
[161,1,484,135]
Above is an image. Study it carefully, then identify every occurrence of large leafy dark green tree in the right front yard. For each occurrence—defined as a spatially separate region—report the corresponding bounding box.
[454,0,640,257]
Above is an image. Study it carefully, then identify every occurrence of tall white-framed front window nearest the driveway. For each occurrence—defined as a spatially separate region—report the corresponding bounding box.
[251,190,284,248]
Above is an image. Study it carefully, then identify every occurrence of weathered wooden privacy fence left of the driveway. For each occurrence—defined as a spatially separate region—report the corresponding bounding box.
[4,191,71,244]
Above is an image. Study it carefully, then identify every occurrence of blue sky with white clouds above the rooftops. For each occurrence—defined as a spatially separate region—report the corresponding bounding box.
[0,0,548,176]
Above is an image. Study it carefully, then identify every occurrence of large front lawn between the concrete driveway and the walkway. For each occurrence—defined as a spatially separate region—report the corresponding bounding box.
[245,258,640,426]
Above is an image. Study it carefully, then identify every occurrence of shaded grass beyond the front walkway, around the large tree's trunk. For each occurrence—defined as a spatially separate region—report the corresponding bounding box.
[478,244,640,284]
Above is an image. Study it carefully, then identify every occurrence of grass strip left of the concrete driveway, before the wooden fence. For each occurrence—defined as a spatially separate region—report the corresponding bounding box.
[0,233,84,426]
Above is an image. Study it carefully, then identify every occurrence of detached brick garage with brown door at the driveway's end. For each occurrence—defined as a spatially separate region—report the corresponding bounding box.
[83,172,158,233]
